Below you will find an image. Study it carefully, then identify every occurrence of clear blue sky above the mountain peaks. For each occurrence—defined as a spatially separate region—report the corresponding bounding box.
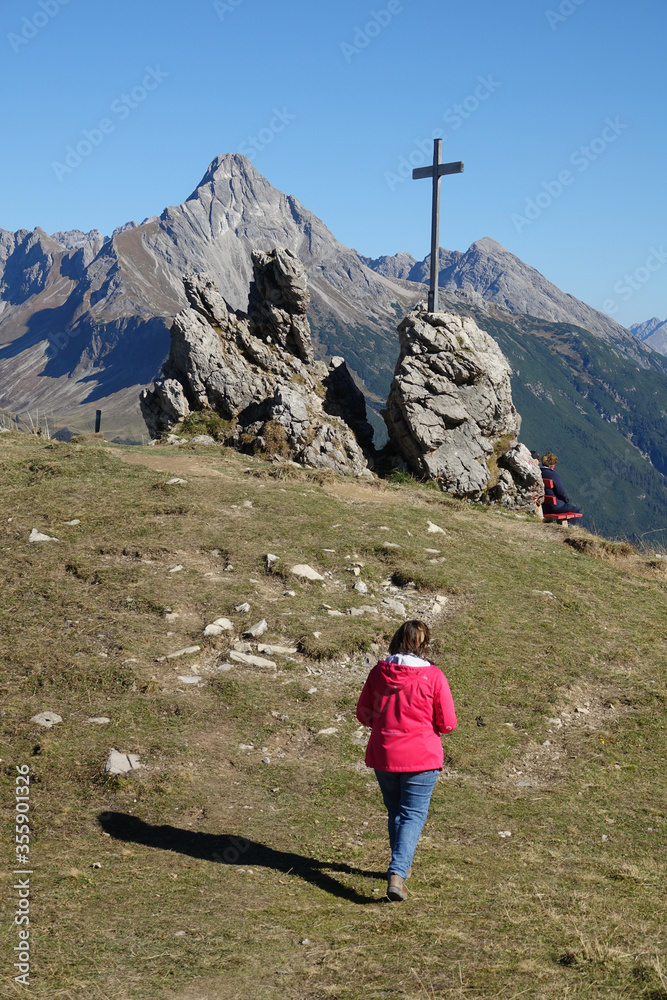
[0,0,667,324]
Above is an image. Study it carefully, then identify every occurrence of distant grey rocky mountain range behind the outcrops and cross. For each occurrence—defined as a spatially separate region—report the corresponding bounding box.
[0,155,667,537]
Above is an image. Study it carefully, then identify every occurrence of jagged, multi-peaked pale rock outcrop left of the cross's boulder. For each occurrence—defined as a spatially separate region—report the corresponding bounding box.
[141,249,372,477]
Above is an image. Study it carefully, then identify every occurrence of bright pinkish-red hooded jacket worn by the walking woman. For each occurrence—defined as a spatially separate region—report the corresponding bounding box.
[357,654,456,771]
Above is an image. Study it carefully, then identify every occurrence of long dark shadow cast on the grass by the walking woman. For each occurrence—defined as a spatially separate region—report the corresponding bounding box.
[98,812,386,905]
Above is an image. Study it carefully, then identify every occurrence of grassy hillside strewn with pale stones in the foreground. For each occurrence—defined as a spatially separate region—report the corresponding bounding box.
[0,434,667,1000]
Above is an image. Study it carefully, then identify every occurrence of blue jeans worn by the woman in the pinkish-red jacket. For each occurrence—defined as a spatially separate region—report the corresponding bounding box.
[375,771,439,878]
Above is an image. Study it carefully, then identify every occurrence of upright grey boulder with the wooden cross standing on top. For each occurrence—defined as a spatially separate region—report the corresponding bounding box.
[384,307,539,510]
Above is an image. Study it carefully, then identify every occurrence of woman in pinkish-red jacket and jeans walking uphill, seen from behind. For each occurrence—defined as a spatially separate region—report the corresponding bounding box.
[357,621,456,902]
